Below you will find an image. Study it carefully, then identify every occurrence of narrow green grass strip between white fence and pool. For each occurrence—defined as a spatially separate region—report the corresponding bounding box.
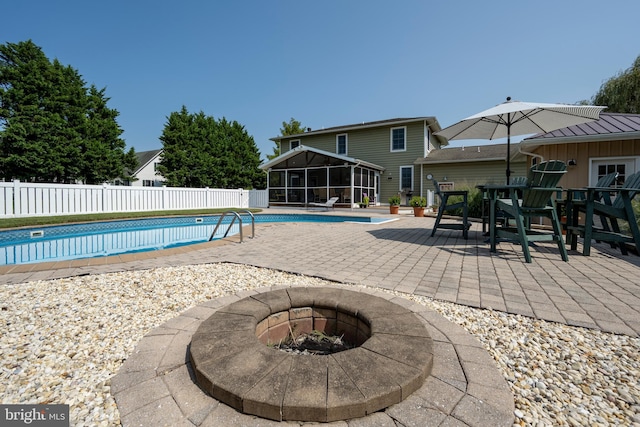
[0,208,262,229]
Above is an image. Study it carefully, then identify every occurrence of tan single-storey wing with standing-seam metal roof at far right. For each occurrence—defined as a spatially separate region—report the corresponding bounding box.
[520,113,640,188]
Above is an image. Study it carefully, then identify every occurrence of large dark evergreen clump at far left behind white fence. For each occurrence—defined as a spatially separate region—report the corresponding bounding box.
[0,40,137,184]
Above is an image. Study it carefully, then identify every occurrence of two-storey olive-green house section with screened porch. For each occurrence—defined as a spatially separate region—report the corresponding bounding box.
[261,117,447,207]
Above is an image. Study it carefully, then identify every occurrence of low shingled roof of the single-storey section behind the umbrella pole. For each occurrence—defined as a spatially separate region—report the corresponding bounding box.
[414,143,523,165]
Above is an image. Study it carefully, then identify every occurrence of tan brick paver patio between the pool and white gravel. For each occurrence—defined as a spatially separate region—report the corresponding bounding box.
[0,209,640,336]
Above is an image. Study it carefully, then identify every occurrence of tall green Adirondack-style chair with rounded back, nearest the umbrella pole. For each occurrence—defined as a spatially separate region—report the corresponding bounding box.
[487,160,569,263]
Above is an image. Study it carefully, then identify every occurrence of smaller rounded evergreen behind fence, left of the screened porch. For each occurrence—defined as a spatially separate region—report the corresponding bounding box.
[158,106,266,188]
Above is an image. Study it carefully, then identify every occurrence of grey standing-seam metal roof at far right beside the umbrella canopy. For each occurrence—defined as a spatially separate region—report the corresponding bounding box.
[522,113,640,144]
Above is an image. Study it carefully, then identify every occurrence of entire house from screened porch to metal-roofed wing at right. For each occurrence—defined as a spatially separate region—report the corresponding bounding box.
[261,113,640,207]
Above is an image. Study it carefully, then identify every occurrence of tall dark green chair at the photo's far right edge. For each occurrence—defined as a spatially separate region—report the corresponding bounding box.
[567,172,640,256]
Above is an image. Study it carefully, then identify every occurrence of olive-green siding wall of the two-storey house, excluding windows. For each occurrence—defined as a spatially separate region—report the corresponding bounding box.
[281,121,426,204]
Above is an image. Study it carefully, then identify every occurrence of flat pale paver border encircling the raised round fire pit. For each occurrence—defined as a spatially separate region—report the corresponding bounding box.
[111,285,515,427]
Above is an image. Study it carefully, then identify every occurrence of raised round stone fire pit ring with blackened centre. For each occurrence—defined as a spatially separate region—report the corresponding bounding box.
[189,287,433,422]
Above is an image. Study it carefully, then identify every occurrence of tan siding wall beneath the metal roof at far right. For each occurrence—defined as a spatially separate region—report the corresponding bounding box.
[533,139,640,188]
